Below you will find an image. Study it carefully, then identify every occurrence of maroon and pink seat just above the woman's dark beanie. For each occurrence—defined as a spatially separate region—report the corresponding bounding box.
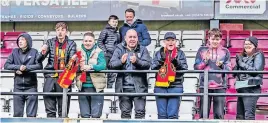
[229,30,250,48]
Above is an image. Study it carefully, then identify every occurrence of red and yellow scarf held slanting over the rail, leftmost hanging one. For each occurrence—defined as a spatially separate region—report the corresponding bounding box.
[58,51,86,88]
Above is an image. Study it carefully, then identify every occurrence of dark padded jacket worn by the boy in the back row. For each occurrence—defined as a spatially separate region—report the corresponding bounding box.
[98,24,120,58]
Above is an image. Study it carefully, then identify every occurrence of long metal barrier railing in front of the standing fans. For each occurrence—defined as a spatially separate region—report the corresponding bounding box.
[1,70,268,119]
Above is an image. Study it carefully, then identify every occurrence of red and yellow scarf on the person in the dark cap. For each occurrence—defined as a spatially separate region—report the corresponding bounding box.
[155,48,178,87]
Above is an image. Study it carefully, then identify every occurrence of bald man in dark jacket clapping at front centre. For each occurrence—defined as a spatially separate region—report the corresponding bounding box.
[109,29,151,119]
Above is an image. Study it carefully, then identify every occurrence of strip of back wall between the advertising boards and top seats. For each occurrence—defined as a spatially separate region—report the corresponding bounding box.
[1,20,268,31]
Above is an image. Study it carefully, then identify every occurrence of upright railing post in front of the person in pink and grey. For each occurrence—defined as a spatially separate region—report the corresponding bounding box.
[203,70,209,119]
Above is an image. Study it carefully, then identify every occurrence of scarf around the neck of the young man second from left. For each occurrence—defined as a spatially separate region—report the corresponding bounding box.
[52,41,67,77]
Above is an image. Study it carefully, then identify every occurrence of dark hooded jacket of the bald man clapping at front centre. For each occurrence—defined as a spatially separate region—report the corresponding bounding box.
[108,42,151,93]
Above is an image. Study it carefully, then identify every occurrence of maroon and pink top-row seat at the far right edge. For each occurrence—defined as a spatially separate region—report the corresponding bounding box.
[252,30,268,48]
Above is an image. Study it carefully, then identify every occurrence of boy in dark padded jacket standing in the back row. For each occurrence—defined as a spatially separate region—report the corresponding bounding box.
[98,15,120,88]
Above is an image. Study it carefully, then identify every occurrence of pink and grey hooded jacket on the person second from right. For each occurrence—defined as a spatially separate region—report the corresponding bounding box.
[194,46,231,89]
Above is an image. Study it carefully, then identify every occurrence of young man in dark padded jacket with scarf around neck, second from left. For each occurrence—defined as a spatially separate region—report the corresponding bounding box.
[39,22,76,117]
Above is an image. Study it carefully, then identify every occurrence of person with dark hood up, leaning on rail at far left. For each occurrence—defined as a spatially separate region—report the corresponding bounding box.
[4,33,43,117]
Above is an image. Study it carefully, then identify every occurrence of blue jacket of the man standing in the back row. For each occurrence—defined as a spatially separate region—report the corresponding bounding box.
[119,19,151,47]
